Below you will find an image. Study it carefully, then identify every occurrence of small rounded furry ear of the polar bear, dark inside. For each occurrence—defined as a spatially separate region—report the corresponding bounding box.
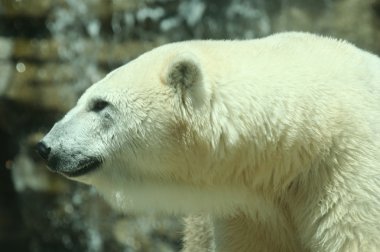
[164,53,203,92]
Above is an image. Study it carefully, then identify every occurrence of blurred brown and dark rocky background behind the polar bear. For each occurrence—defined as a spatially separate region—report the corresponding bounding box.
[0,0,380,252]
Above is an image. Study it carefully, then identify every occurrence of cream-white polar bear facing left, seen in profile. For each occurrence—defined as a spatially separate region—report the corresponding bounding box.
[37,33,380,252]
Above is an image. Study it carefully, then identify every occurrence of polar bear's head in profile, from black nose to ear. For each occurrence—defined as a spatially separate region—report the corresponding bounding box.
[37,46,243,212]
